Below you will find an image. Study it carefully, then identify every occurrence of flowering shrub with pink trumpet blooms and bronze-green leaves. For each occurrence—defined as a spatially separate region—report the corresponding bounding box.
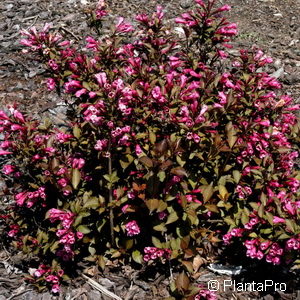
[0,0,300,299]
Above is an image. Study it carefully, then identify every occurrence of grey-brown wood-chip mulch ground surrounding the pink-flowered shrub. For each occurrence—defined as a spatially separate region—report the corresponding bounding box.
[0,0,300,300]
